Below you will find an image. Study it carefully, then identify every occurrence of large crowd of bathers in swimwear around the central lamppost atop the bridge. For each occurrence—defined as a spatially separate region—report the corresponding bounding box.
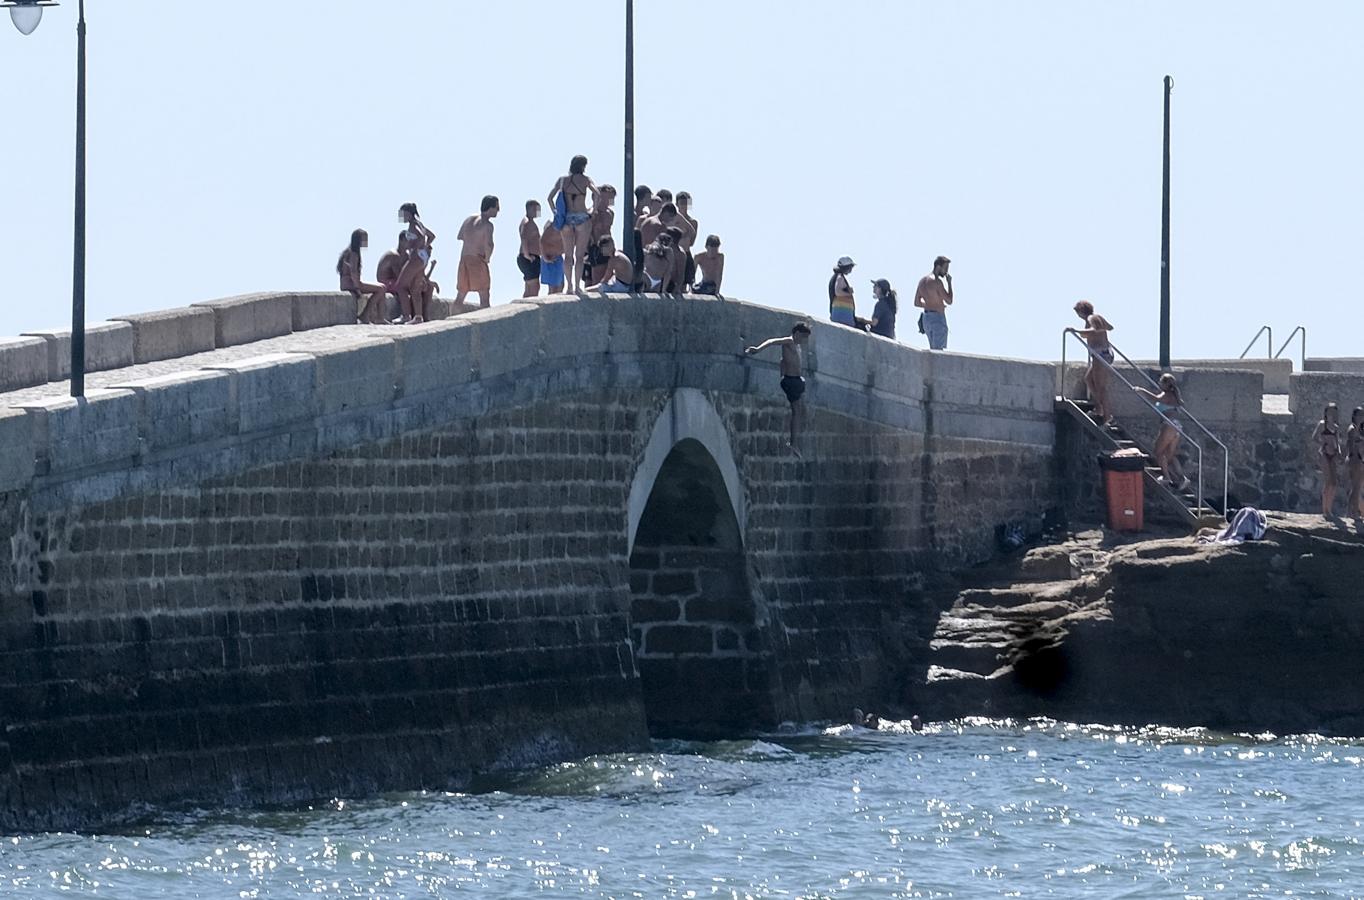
[337,155,724,325]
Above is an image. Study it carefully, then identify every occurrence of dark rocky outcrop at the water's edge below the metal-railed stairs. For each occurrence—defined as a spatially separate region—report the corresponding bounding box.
[906,513,1364,735]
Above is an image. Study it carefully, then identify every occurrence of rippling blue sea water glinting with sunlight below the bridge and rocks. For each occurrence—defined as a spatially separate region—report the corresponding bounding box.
[0,720,1364,899]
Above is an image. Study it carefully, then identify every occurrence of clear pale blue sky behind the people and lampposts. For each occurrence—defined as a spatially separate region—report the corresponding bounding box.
[0,0,1364,359]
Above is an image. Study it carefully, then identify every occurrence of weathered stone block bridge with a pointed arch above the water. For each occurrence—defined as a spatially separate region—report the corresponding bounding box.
[0,295,1074,829]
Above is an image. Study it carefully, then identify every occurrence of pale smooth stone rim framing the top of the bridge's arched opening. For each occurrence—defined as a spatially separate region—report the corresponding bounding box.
[626,387,747,554]
